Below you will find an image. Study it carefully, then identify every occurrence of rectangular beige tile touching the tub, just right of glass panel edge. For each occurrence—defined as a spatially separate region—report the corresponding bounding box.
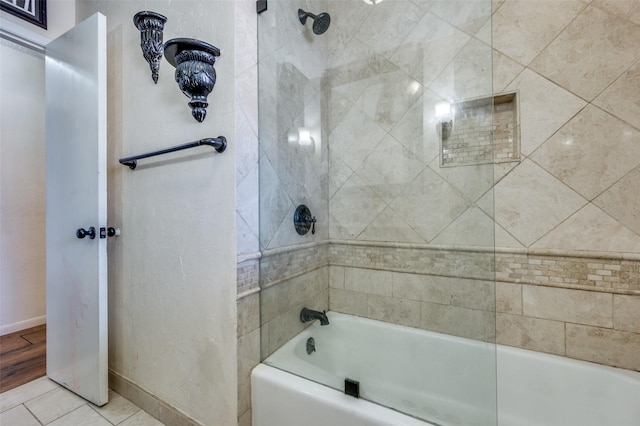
[496,314,565,355]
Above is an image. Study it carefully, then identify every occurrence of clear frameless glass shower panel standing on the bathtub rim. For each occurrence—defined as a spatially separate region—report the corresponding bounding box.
[259,0,496,425]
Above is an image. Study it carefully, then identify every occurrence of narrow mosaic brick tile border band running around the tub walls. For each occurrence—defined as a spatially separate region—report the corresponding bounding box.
[256,241,640,295]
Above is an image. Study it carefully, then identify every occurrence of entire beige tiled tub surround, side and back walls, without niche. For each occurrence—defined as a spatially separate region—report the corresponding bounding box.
[238,0,640,424]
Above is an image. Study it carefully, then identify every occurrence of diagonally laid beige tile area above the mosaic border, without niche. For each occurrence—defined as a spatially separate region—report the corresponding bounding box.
[261,0,640,256]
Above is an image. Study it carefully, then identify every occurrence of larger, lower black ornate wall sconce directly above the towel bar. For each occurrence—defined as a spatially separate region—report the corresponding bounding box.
[164,38,220,122]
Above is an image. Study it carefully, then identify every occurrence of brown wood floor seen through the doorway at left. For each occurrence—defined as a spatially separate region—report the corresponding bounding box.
[0,325,47,393]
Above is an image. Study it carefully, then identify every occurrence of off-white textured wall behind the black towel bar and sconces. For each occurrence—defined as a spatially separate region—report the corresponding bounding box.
[77,1,238,425]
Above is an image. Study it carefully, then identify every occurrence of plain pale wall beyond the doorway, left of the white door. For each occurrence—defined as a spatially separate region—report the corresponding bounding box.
[0,40,46,335]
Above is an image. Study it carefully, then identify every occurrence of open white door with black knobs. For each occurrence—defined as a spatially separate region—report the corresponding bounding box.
[45,14,108,405]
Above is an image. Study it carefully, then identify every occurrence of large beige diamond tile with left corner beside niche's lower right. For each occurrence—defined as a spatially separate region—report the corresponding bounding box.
[531,106,640,200]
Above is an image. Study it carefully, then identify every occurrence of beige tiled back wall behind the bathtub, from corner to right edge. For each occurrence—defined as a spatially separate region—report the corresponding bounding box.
[329,0,640,369]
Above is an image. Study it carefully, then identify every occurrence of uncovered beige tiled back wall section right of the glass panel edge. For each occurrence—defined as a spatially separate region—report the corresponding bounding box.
[484,0,640,370]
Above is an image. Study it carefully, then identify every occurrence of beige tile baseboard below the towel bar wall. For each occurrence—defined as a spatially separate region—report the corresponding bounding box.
[109,369,203,426]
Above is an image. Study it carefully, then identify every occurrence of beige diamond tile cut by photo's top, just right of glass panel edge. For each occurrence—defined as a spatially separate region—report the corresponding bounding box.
[492,0,584,65]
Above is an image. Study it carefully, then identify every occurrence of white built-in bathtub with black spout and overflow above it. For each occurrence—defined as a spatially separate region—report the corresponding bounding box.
[252,312,640,426]
